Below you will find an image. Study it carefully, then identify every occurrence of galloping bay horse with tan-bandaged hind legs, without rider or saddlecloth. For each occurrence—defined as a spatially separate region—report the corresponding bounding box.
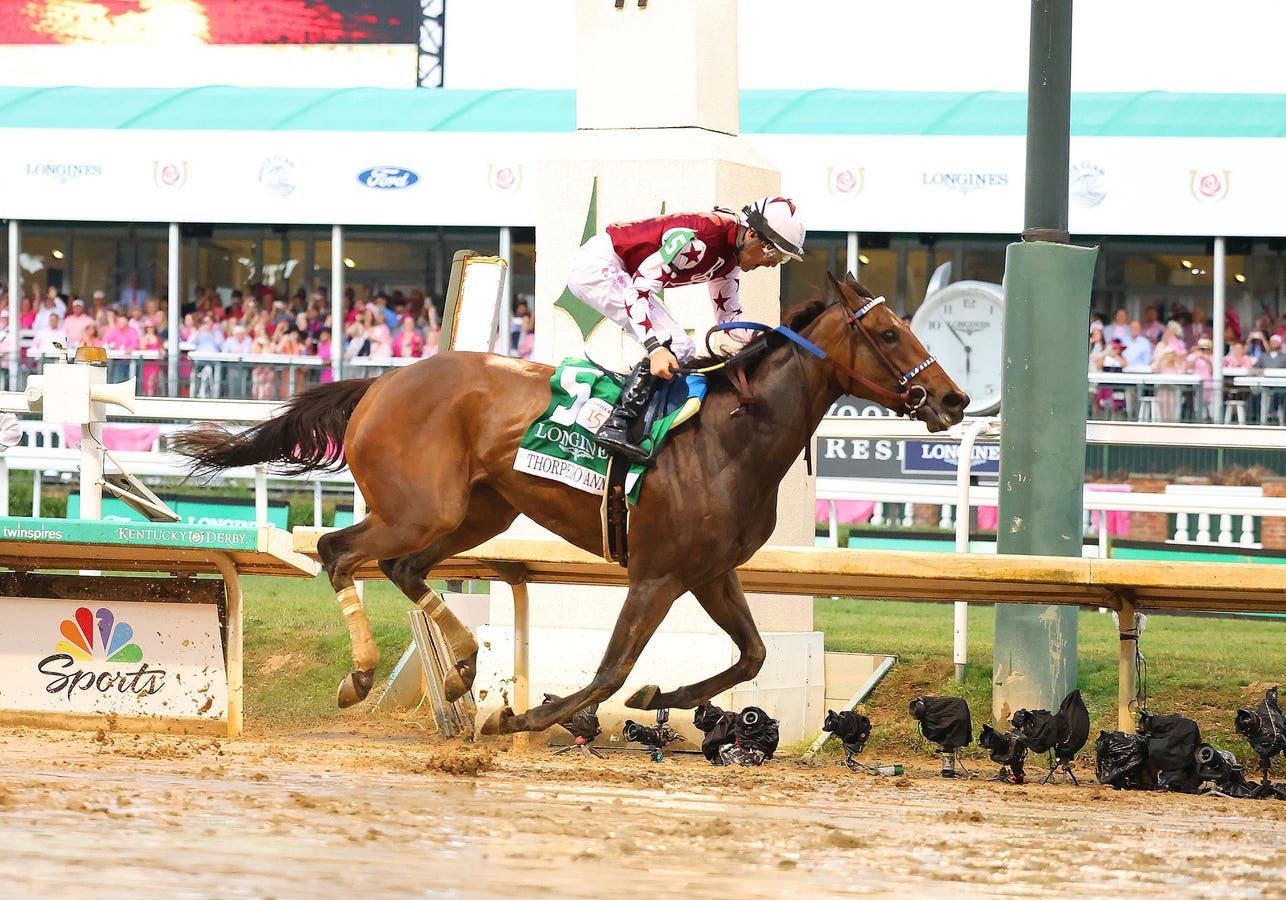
[175,275,968,734]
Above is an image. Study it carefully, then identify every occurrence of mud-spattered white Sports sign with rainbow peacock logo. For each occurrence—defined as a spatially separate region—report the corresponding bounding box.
[0,598,228,721]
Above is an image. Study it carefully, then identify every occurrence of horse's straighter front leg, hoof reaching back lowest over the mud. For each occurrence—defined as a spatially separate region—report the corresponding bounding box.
[482,576,684,734]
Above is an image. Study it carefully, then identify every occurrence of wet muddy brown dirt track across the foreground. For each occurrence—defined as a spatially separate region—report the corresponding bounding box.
[0,729,1286,897]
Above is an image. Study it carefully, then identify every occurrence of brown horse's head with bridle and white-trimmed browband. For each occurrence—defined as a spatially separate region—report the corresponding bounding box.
[810,273,968,431]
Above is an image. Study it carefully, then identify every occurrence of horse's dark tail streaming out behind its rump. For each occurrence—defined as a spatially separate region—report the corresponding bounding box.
[171,378,376,477]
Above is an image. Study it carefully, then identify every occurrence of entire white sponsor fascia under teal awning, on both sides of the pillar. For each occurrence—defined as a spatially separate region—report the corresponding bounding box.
[0,129,1286,237]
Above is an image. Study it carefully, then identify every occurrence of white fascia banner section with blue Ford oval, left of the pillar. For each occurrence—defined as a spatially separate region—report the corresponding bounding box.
[0,129,547,226]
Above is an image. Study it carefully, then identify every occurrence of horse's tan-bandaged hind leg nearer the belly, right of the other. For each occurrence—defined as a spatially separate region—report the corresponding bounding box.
[379,486,518,702]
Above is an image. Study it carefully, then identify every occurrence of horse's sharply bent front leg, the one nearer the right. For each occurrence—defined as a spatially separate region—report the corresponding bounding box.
[625,570,765,710]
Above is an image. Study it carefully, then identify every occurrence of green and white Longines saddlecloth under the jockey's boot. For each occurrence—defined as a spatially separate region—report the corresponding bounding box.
[513,357,706,503]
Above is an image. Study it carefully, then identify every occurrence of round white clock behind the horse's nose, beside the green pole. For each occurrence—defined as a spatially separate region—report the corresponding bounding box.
[910,282,1004,415]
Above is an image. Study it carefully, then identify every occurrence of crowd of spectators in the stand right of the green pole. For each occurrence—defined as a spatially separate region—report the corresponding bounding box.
[1089,298,1286,420]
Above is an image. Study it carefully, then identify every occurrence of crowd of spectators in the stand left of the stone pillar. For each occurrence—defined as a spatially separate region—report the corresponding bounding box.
[0,278,534,400]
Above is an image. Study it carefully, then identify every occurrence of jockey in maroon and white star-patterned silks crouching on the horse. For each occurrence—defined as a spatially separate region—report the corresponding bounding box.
[567,197,805,460]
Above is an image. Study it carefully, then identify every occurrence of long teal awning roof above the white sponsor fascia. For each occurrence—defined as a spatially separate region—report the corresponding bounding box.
[0,86,1286,138]
